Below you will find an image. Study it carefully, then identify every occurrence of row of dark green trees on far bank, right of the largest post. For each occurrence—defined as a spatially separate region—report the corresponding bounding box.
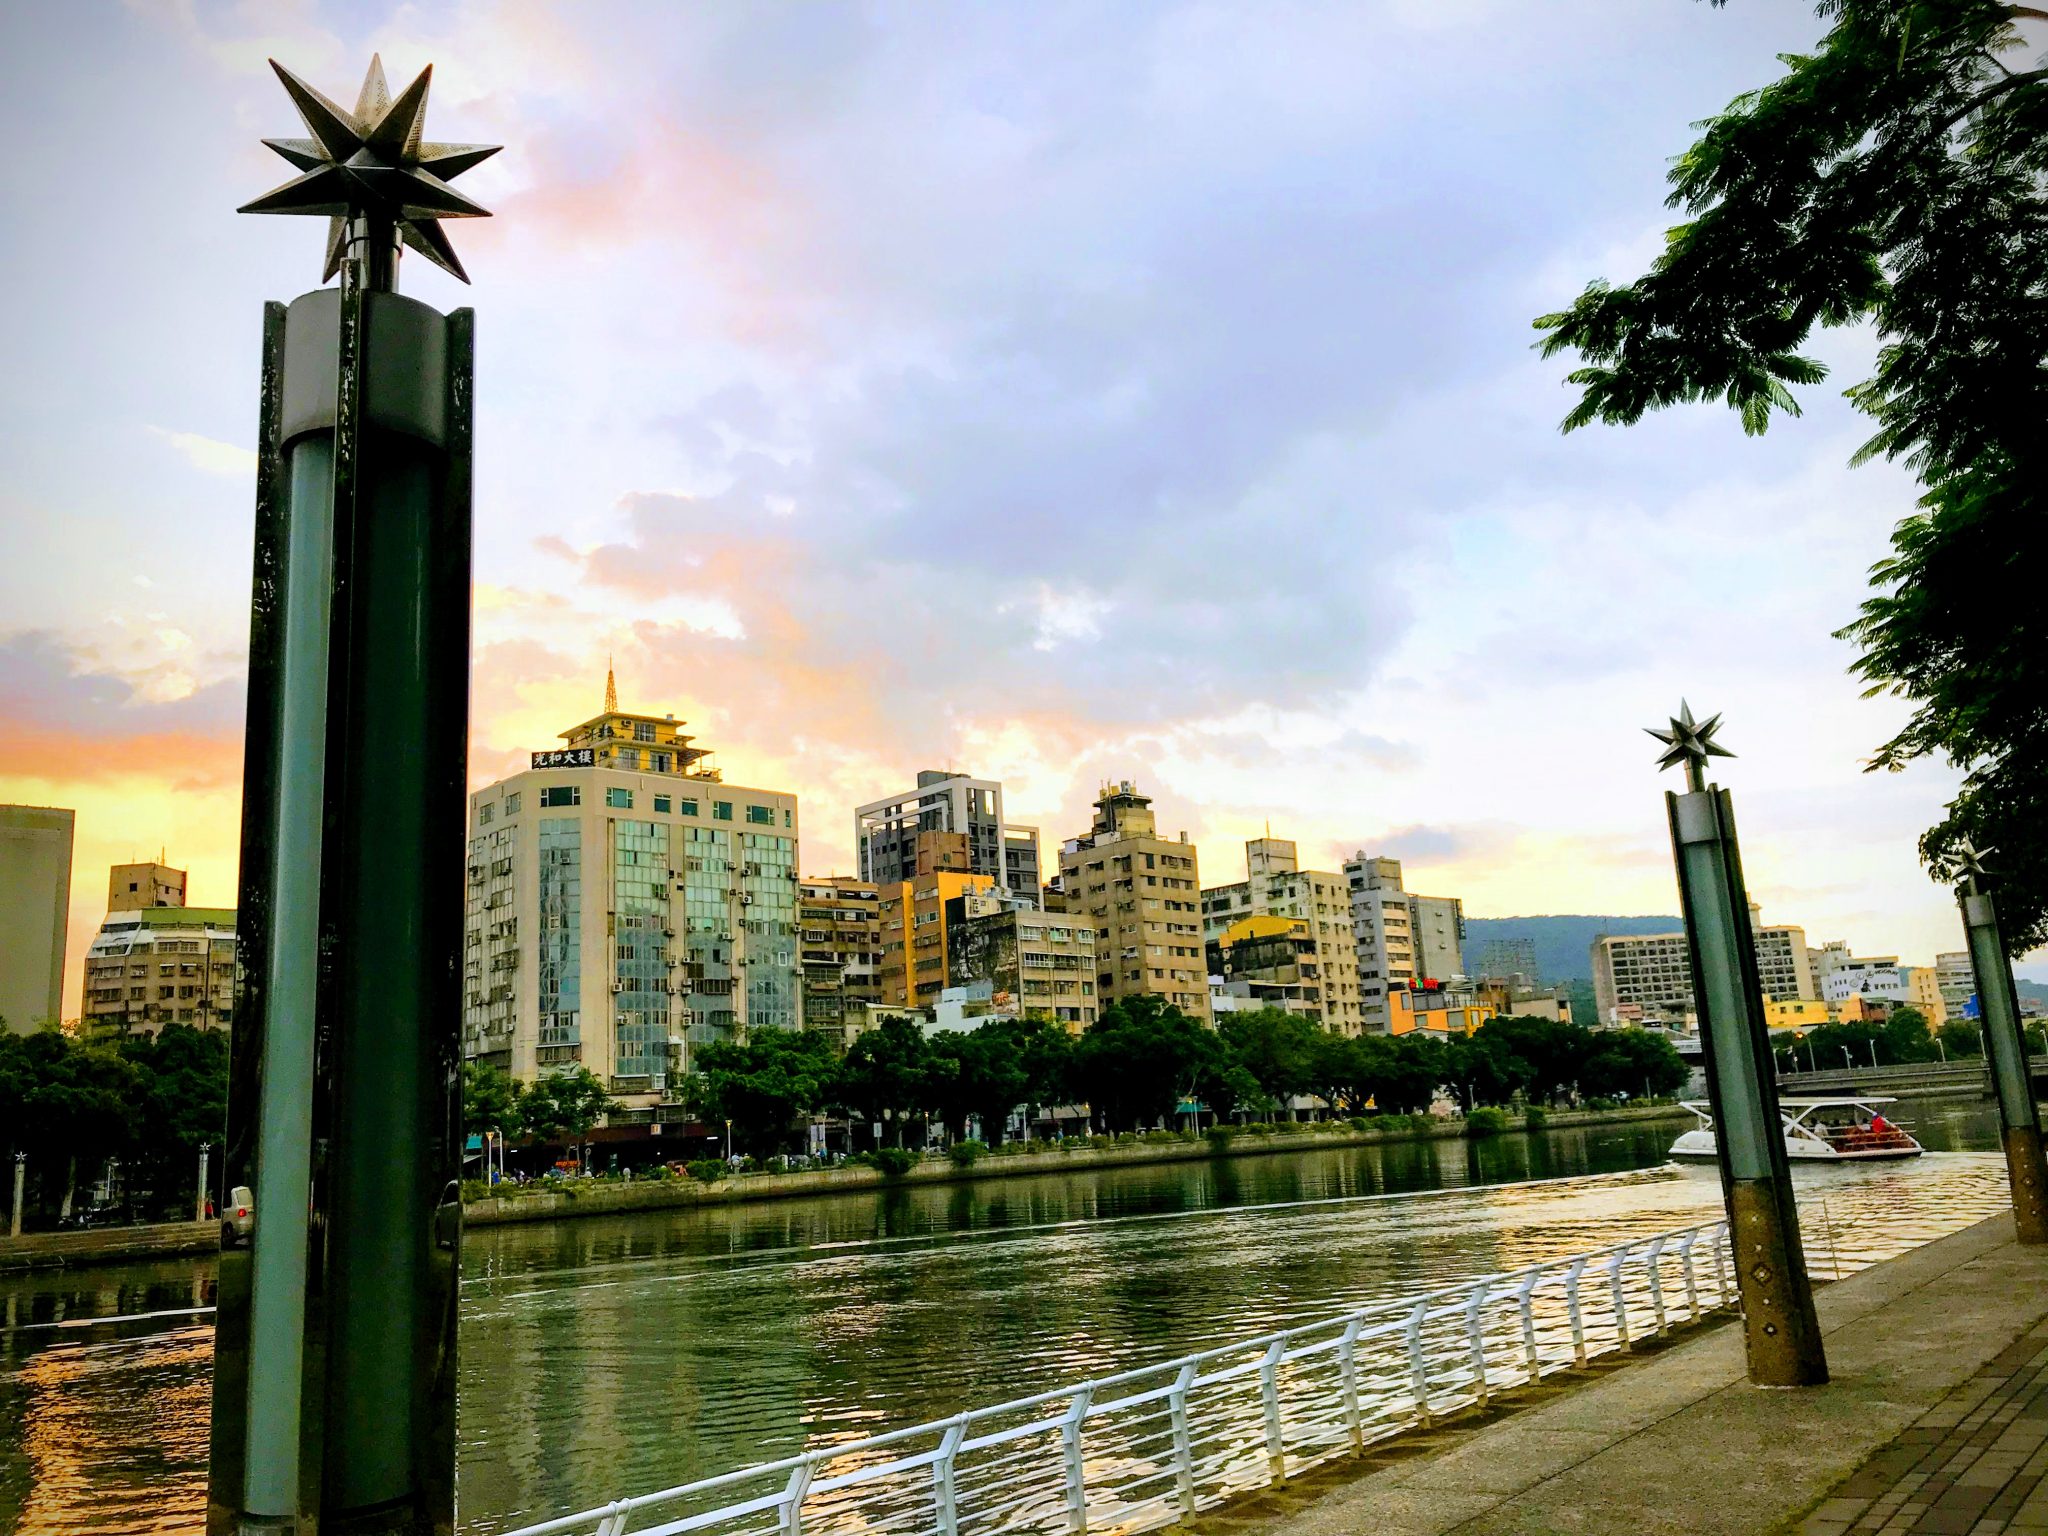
[465,997,1686,1157]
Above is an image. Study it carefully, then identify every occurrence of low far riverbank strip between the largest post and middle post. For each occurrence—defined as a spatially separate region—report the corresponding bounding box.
[463,1104,1692,1227]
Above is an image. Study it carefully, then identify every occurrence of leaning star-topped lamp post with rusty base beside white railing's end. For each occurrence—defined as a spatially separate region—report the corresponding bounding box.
[1651,705,1827,1386]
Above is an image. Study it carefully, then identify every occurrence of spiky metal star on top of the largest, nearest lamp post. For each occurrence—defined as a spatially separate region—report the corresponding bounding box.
[240,53,504,283]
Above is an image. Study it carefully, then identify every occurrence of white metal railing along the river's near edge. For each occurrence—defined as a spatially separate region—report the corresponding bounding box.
[506,1223,1735,1536]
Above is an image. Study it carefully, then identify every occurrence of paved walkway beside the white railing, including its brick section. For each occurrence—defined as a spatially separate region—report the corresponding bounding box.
[1190,1217,2048,1536]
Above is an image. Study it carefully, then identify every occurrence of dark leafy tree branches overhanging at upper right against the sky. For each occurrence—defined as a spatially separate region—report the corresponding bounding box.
[1536,0,2048,954]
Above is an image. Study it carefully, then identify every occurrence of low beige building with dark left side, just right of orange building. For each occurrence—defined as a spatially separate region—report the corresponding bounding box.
[946,891,1098,1034]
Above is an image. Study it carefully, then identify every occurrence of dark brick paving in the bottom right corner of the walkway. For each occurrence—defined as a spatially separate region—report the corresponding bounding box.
[1798,1323,2048,1536]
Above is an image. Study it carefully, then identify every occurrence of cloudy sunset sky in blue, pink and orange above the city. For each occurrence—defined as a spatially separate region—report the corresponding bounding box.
[0,0,2023,1024]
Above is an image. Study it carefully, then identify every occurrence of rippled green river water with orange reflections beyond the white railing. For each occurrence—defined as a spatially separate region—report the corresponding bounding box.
[0,1102,2007,1536]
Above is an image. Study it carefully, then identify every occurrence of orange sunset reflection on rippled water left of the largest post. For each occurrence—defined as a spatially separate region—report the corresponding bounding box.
[14,1327,213,1536]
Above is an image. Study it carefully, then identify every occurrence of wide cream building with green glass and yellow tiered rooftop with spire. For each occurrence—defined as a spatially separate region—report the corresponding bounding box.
[463,678,801,1122]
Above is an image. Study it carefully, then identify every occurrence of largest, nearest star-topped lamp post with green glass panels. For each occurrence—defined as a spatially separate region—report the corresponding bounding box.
[207,48,496,1536]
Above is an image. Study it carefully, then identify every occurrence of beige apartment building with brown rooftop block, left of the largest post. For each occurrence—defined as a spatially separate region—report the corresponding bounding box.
[80,862,236,1038]
